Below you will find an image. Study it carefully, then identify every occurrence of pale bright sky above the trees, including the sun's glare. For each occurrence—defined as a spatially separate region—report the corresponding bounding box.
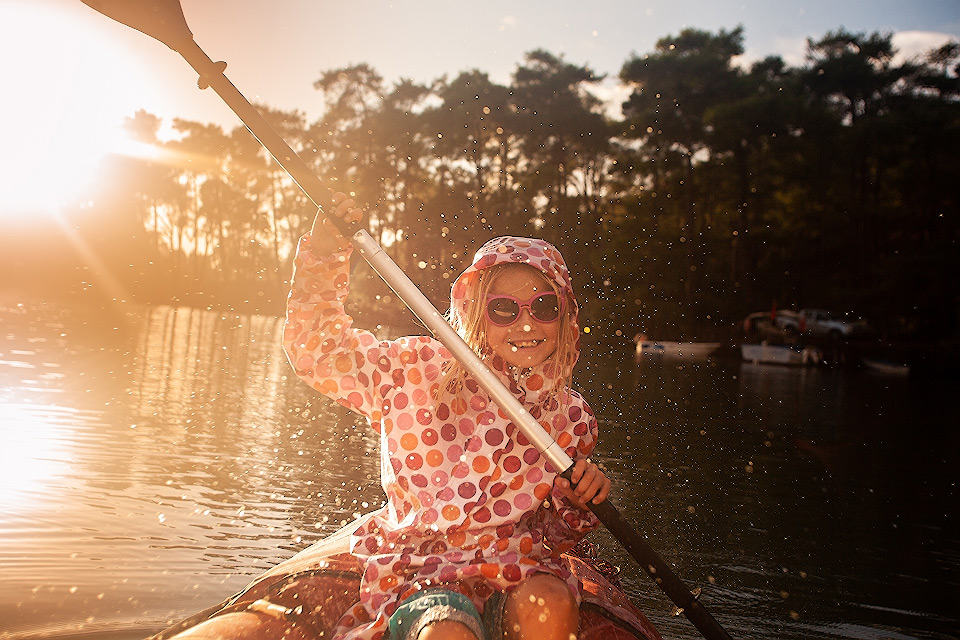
[0,0,960,215]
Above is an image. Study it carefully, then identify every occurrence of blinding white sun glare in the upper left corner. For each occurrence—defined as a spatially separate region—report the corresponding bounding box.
[0,0,171,223]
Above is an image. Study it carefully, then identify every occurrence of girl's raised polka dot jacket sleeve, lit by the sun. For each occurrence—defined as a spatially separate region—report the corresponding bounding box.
[283,234,402,430]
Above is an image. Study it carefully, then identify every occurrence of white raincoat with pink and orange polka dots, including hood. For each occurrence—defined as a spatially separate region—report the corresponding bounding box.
[284,235,597,640]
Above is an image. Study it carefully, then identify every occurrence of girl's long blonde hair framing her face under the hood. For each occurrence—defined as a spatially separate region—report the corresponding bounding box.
[437,263,578,400]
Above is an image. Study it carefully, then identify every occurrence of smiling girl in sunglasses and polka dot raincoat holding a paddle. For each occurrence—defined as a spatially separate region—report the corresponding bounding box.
[284,194,610,640]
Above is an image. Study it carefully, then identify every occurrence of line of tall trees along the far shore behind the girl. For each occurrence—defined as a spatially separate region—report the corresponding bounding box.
[9,28,960,339]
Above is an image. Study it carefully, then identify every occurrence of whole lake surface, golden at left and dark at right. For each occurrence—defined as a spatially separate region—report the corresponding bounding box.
[0,300,960,640]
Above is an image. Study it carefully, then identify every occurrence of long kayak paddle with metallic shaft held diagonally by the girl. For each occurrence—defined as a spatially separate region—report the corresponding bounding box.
[81,0,730,640]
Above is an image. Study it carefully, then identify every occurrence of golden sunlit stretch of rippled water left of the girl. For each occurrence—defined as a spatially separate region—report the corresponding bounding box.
[0,305,379,637]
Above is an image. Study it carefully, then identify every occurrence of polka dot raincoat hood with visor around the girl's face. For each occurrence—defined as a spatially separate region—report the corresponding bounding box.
[450,236,580,388]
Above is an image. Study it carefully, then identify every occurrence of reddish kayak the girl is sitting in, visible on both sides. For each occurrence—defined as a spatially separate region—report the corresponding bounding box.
[149,527,662,640]
